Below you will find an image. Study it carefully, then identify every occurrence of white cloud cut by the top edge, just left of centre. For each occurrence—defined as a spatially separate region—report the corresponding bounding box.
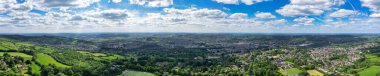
[129,0,173,7]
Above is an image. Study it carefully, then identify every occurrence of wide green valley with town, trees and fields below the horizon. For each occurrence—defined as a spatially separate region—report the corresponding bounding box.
[0,33,380,76]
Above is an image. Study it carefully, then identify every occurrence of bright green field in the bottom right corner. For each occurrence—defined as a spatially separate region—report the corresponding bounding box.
[359,66,380,76]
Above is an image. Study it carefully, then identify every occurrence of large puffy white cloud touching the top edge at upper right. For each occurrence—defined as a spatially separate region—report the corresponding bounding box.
[276,0,344,16]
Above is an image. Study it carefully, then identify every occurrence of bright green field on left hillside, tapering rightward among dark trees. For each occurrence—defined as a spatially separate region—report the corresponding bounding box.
[36,53,71,68]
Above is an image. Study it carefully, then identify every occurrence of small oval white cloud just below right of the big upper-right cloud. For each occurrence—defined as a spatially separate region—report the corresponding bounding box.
[329,9,357,17]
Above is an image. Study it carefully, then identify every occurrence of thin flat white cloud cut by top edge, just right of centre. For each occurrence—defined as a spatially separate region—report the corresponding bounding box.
[214,0,270,5]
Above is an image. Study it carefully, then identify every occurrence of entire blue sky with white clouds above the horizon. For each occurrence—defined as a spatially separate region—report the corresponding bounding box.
[0,0,380,33]
